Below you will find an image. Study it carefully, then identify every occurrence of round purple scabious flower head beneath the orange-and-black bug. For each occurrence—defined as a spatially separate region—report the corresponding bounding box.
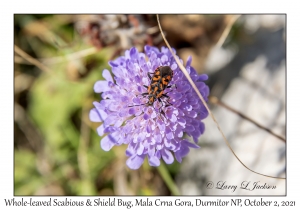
[90,46,209,169]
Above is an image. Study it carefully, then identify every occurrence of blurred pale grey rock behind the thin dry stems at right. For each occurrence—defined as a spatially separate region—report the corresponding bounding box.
[177,16,286,195]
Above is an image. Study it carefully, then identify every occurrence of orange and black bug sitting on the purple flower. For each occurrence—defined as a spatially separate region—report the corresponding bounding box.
[130,66,173,110]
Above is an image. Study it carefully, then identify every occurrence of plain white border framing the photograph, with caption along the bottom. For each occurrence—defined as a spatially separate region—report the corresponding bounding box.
[0,0,300,209]
